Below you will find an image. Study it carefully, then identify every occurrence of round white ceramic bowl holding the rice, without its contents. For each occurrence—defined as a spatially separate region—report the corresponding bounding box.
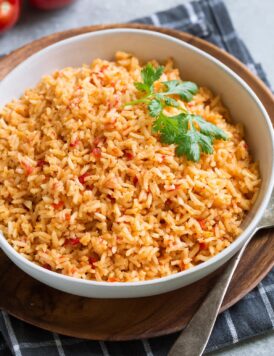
[0,29,274,298]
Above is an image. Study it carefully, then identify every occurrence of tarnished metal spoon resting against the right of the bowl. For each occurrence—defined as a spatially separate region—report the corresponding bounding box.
[168,192,274,356]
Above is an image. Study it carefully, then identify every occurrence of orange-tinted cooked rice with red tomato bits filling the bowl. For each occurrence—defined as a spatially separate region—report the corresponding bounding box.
[0,52,260,282]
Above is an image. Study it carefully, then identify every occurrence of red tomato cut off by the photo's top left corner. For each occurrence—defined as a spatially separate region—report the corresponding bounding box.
[0,0,20,32]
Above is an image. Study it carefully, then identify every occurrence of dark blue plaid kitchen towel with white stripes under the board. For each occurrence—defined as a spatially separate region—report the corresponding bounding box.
[0,0,274,356]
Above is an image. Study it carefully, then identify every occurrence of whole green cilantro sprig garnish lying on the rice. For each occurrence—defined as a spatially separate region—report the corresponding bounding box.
[126,64,228,162]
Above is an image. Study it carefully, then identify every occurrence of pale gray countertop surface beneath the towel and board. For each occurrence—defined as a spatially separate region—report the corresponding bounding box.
[0,0,274,356]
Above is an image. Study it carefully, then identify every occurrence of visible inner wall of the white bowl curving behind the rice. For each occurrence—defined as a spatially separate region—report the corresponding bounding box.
[0,29,273,292]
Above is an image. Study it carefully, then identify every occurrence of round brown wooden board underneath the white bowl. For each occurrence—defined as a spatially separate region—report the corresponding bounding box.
[0,24,274,340]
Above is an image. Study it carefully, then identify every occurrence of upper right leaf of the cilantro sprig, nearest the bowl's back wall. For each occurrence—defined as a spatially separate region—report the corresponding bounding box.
[163,80,198,102]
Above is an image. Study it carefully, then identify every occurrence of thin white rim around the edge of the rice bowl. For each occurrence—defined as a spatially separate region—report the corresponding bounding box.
[0,28,274,288]
